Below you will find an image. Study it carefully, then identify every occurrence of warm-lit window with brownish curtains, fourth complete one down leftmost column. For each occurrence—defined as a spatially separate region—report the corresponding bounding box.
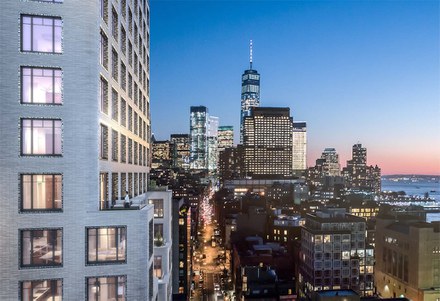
[20,174,62,211]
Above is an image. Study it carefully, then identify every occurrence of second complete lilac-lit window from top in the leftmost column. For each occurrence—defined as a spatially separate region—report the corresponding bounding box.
[21,67,62,104]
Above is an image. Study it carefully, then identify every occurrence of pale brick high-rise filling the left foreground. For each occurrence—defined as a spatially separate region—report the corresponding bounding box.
[0,0,171,300]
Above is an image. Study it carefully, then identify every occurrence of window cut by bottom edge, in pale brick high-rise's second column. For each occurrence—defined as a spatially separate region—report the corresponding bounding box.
[87,276,127,301]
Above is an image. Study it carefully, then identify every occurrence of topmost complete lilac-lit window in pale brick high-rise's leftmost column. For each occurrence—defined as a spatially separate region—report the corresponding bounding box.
[21,15,63,53]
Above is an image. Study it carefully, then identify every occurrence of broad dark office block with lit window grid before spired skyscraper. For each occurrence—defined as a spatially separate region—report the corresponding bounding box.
[243,107,293,178]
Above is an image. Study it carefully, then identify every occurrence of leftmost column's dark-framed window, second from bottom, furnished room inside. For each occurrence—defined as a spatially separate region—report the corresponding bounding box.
[20,229,63,267]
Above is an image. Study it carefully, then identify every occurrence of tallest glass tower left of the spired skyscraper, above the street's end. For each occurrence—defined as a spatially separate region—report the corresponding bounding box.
[190,106,208,169]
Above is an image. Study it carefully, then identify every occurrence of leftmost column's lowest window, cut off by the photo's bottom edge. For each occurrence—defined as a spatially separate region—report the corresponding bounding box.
[20,279,63,301]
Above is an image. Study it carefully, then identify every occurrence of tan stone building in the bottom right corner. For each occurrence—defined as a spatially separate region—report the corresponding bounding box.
[374,215,440,301]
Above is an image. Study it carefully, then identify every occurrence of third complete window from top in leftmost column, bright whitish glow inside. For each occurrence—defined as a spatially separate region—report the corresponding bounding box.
[21,119,62,156]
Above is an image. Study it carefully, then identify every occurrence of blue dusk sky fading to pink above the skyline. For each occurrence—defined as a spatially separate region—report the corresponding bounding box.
[150,0,440,174]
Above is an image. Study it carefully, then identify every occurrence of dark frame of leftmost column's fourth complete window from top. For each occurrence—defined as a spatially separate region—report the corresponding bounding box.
[19,173,63,213]
